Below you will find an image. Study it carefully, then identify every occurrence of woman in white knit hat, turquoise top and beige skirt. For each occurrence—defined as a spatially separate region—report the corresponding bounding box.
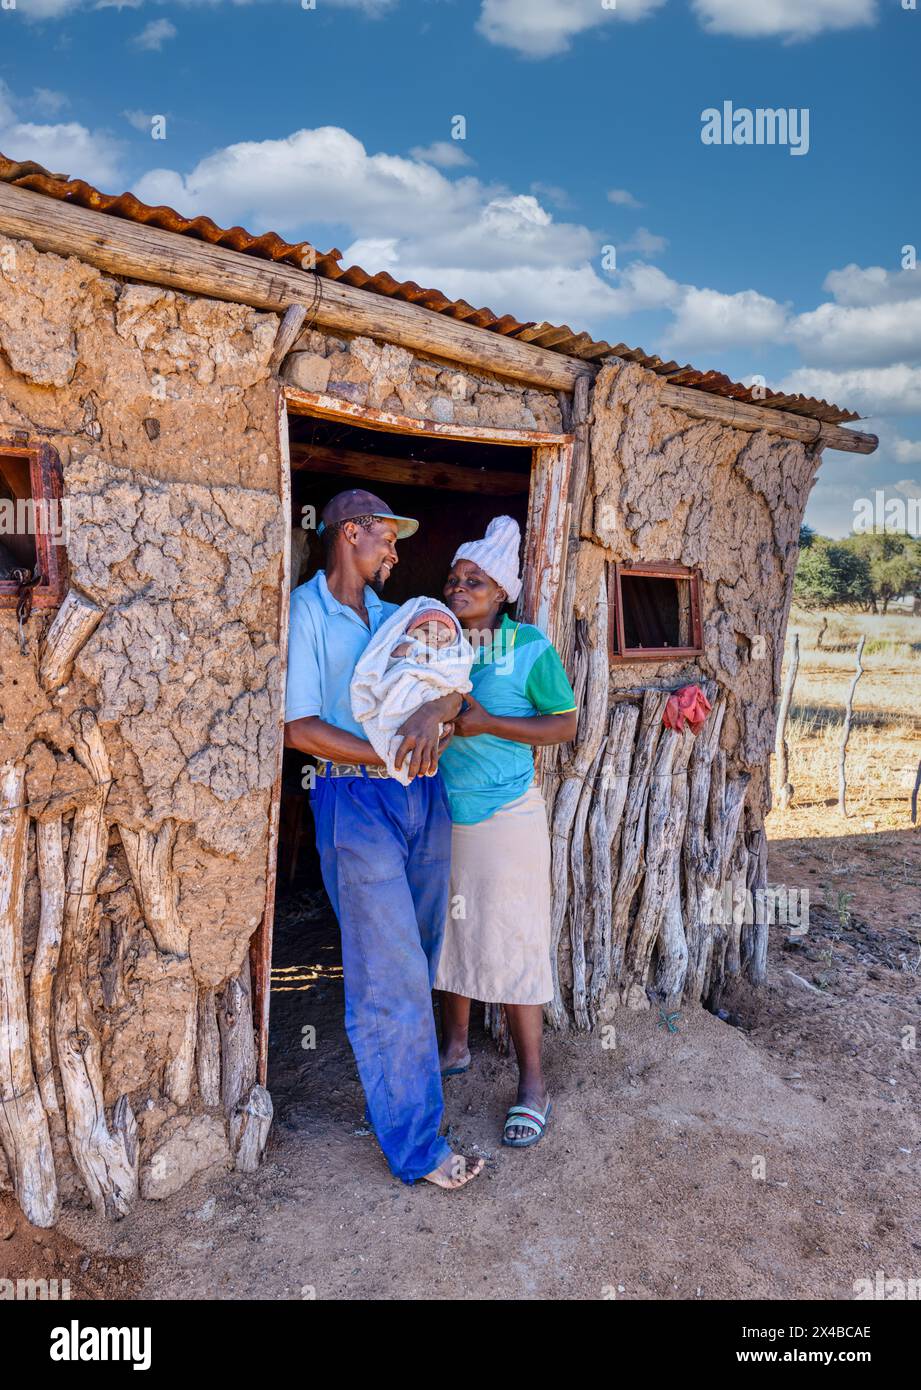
[435,517,576,1148]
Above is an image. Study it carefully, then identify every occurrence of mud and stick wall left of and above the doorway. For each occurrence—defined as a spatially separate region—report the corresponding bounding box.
[0,236,560,1225]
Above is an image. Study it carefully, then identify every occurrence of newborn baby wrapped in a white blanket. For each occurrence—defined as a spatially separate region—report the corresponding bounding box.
[350,598,474,787]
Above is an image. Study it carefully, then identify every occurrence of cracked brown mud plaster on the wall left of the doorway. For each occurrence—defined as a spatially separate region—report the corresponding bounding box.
[0,238,285,1101]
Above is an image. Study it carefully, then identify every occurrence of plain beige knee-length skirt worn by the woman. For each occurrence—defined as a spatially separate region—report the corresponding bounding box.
[435,787,553,1004]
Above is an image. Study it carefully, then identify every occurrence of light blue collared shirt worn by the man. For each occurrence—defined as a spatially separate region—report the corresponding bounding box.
[285,570,399,738]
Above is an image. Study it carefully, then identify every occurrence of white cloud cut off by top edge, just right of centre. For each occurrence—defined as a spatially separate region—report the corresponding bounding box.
[476,0,664,58]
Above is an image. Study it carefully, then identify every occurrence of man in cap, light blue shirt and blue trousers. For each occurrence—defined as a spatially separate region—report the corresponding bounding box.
[285,488,482,1188]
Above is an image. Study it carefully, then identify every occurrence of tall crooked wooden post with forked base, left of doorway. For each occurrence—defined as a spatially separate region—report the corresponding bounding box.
[54,710,139,1218]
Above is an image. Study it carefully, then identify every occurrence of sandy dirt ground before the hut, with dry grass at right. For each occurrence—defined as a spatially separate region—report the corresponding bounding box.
[0,608,921,1300]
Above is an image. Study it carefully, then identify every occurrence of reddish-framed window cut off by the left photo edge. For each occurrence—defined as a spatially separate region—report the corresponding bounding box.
[0,439,67,607]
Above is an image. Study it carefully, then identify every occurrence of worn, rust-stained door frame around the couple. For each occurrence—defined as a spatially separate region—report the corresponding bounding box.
[250,385,575,1086]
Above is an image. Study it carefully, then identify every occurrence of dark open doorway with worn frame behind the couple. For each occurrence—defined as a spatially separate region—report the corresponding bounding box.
[251,391,572,1084]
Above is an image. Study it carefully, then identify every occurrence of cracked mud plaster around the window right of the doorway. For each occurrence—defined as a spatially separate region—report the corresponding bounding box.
[576,361,821,828]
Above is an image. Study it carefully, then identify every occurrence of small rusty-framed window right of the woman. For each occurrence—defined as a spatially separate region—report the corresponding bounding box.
[607,564,703,662]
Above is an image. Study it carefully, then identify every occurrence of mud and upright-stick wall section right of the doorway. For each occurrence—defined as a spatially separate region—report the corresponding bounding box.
[545,360,820,1029]
